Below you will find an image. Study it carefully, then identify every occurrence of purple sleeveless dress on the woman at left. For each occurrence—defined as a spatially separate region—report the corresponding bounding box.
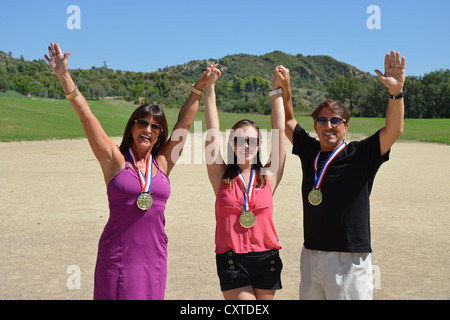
[94,155,170,300]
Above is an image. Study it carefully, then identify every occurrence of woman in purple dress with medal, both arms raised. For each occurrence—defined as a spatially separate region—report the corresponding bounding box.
[45,43,211,300]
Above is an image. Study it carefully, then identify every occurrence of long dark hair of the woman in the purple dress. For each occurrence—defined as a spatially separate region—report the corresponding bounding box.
[119,104,169,158]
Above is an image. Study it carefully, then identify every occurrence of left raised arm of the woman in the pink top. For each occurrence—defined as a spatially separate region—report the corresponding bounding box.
[205,66,226,195]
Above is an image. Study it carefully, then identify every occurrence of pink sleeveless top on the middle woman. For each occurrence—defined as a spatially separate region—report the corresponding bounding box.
[216,179,281,254]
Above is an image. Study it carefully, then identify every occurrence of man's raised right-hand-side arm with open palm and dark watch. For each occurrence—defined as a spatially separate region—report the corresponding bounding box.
[375,50,406,156]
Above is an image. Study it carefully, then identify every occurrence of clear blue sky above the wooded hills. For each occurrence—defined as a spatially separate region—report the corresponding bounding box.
[0,0,450,76]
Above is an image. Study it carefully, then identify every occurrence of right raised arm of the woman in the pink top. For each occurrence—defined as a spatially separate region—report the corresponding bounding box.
[264,67,286,193]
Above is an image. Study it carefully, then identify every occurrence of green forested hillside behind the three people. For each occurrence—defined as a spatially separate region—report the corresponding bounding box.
[0,51,450,118]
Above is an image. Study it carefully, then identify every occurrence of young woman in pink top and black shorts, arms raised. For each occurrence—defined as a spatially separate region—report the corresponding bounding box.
[205,65,286,300]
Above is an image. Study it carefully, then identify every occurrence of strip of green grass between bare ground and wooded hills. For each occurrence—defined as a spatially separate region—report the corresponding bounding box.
[0,95,450,145]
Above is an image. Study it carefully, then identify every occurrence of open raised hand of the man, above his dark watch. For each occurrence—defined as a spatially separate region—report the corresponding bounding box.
[375,50,406,94]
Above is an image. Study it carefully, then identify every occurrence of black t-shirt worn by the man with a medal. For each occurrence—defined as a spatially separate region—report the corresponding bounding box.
[292,124,390,252]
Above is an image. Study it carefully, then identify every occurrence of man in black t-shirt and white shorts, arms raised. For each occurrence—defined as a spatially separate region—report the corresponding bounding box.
[280,51,405,299]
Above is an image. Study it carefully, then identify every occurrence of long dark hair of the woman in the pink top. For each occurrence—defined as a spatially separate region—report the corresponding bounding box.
[222,119,266,187]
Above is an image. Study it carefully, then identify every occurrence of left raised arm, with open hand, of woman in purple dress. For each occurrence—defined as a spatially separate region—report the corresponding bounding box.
[45,42,125,184]
